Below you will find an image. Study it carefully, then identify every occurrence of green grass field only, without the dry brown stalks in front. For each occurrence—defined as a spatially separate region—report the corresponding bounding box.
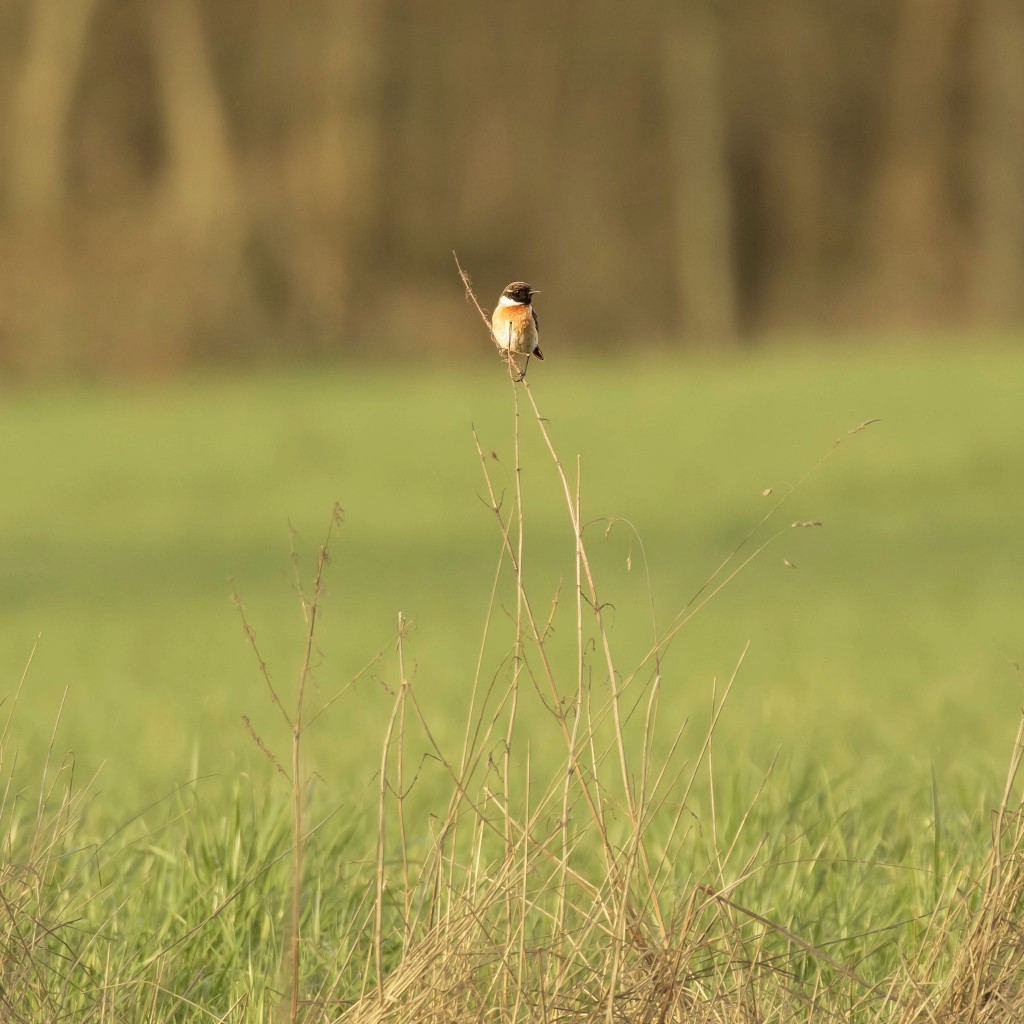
[0,346,1024,1021]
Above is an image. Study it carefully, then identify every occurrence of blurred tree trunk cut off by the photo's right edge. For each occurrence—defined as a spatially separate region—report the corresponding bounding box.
[971,0,1024,326]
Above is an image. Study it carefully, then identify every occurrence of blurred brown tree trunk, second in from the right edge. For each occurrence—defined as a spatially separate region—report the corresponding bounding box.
[866,0,959,323]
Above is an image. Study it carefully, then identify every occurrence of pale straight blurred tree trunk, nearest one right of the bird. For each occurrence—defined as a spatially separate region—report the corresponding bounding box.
[662,0,737,341]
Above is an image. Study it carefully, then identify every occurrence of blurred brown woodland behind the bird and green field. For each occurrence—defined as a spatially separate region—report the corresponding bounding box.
[0,0,1024,375]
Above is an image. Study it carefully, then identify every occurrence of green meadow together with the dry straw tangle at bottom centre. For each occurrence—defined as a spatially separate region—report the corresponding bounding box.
[0,343,1024,1021]
